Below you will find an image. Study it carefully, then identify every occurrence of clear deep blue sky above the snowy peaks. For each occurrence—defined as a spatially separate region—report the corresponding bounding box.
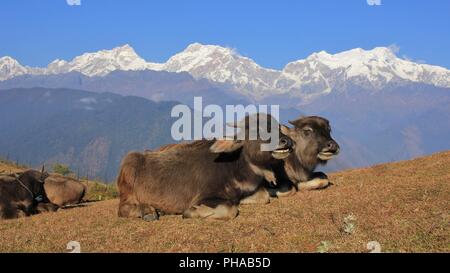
[0,0,450,68]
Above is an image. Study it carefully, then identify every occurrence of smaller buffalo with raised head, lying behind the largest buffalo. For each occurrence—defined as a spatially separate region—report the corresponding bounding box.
[269,116,340,196]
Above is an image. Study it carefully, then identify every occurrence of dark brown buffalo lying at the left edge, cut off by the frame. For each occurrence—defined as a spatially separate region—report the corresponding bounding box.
[0,169,48,219]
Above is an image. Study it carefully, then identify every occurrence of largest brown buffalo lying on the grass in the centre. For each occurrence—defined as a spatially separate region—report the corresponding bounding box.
[117,113,292,221]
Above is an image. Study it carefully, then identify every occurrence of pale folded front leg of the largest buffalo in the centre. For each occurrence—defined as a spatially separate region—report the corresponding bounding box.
[183,199,239,220]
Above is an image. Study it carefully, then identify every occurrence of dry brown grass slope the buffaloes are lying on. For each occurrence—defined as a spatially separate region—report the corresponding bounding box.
[0,152,450,252]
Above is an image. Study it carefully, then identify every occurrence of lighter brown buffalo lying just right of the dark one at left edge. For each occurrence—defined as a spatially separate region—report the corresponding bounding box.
[44,174,86,207]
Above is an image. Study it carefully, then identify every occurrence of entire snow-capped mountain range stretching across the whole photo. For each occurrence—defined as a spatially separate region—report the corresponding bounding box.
[0,43,450,100]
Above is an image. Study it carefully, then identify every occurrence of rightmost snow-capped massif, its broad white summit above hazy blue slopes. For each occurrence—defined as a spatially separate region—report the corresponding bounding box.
[274,47,450,100]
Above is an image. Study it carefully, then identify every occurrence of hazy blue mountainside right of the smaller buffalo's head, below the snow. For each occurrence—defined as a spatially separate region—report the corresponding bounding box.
[301,84,450,169]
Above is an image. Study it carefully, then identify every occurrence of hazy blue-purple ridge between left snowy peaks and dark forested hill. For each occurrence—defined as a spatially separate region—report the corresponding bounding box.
[0,70,250,105]
